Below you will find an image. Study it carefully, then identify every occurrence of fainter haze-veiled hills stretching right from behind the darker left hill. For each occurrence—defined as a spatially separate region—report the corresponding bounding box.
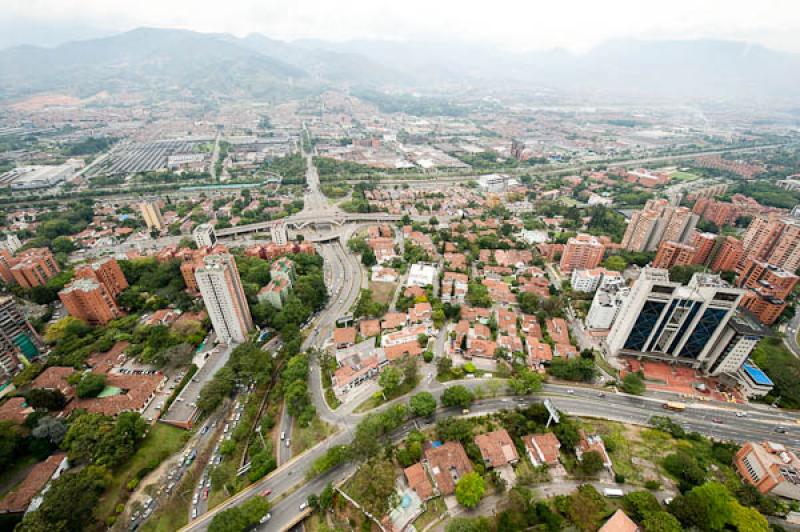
[304,40,800,101]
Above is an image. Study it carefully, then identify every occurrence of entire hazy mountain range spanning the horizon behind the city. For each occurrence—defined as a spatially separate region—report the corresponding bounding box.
[0,28,800,105]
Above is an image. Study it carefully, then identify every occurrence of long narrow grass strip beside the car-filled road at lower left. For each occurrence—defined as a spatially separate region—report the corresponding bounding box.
[97,423,189,521]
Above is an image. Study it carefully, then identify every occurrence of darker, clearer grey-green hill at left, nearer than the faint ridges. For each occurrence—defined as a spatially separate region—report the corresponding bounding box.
[0,28,308,97]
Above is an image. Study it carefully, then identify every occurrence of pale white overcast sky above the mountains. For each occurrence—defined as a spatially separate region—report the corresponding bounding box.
[0,0,800,52]
